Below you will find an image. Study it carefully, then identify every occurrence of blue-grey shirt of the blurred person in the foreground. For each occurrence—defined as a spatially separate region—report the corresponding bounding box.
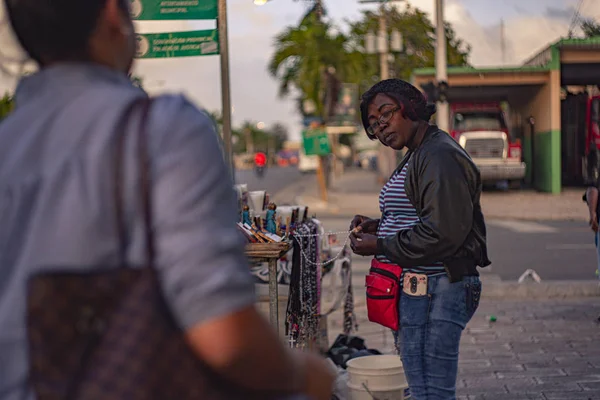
[0,64,254,400]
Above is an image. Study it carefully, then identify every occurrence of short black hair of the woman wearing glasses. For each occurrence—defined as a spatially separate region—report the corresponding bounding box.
[360,79,436,139]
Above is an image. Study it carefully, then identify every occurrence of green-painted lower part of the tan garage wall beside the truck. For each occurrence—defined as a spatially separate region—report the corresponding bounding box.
[524,130,561,194]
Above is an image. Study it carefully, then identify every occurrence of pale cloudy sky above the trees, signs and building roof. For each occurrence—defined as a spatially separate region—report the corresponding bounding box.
[0,0,600,141]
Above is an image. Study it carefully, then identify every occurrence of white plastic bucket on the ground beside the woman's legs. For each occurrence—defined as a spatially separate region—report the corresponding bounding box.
[347,355,409,400]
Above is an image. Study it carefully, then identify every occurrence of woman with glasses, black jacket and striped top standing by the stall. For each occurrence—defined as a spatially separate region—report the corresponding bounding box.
[350,79,491,400]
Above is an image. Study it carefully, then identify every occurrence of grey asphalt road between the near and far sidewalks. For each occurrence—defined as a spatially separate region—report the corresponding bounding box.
[316,218,597,281]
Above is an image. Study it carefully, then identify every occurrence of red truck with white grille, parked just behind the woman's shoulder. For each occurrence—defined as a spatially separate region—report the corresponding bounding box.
[450,102,526,187]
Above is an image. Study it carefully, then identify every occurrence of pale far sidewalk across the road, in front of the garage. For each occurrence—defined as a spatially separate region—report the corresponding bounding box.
[274,169,587,221]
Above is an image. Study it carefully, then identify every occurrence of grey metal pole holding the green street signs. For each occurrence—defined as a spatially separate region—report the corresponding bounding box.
[217,0,235,182]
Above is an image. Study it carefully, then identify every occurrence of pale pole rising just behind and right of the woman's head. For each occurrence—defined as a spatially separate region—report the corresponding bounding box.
[435,0,450,132]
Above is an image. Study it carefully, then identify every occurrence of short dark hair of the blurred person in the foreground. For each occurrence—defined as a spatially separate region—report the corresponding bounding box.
[5,0,128,64]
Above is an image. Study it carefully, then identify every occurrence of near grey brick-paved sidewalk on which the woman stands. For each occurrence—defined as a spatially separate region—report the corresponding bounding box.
[329,291,600,400]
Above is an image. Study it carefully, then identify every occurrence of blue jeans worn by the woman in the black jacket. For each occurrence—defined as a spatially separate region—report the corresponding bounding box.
[395,275,481,400]
